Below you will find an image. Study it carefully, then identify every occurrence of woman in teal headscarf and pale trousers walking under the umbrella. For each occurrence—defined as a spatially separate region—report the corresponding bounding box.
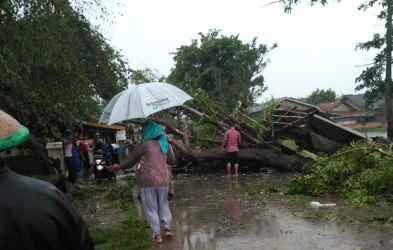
[109,121,175,243]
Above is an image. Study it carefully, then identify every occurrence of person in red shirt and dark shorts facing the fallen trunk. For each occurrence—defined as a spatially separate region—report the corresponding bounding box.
[221,123,241,178]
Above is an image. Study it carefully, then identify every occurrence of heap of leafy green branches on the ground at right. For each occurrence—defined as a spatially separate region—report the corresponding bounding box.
[289,142,393,204]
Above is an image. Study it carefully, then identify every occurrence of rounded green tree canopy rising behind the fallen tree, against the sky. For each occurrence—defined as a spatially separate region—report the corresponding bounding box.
[168,30,277,111]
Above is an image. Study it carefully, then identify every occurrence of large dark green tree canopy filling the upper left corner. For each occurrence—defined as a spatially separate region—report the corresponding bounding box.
[0,0,127,140]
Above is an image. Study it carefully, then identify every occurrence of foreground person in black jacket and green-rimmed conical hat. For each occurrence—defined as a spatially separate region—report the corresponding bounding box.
[0,110,94,250]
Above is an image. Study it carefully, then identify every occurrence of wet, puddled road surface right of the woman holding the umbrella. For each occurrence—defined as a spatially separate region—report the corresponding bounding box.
[139,173,393,250]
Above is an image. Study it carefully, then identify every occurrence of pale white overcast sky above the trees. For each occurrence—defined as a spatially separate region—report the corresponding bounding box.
[100,0,383,101]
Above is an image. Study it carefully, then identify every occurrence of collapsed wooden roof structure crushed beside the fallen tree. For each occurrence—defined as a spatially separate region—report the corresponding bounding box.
[250,97,366,157]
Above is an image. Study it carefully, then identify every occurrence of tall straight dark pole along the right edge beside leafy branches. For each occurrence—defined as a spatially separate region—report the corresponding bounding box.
[385,0,393,139]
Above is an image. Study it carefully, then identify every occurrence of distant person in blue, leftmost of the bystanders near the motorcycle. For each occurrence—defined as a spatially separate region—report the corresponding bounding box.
[63,129,80,186]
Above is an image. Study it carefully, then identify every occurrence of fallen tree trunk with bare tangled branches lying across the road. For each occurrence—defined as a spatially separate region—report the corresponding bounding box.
[142,103,311,171]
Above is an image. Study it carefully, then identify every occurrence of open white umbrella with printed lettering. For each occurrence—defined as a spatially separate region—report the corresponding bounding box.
[98,82,192,125]
